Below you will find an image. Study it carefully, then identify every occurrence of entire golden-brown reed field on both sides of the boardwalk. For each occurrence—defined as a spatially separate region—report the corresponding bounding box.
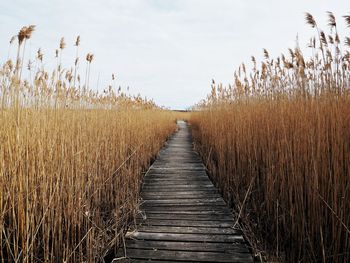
[0,10,350,262]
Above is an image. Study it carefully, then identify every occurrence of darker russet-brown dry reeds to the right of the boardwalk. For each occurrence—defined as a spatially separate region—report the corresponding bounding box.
[191,13,350,262]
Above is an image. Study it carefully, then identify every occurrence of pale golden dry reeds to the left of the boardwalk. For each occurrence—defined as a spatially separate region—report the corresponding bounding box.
[0,26,175,262]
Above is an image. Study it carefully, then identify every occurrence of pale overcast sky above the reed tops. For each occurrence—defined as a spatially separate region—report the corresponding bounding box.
[0,0,350,109]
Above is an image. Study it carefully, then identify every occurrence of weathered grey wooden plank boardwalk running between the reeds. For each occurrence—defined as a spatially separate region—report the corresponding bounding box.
[117,122,253,263]
